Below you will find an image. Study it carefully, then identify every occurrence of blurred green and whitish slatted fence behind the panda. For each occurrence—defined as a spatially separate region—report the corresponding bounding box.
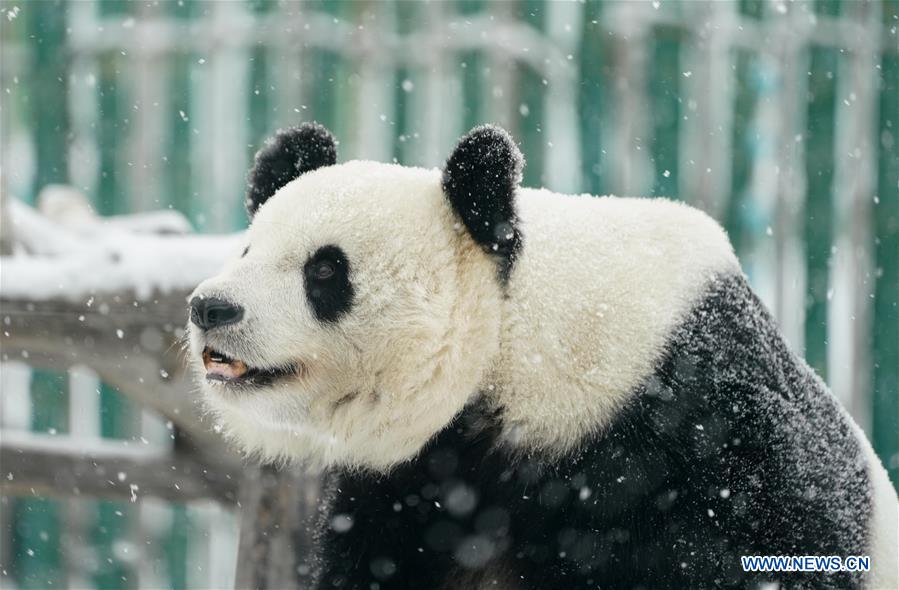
[0,0,899,588]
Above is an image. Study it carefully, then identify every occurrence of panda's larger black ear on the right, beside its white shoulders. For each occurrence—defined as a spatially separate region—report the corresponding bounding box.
[443,125,524,281]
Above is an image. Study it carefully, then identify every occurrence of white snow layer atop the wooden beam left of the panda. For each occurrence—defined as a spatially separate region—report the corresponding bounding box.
[0,198,243,301]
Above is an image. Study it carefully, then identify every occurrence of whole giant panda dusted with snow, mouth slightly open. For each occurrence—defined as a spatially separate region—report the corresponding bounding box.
[189,124,897,590]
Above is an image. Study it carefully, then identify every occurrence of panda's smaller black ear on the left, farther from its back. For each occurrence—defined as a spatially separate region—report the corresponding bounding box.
[246,123,337,217]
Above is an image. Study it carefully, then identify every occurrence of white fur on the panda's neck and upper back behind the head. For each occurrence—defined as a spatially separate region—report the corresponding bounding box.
[491,190,739,453]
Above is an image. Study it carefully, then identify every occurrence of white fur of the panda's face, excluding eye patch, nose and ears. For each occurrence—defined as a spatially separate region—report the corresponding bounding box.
[191,162,500,470]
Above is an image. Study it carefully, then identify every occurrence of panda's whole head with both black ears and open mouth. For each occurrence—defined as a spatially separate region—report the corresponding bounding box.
[189,124,523,470]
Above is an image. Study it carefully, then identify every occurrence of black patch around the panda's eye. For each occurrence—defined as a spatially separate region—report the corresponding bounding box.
[303,245,353,322]
